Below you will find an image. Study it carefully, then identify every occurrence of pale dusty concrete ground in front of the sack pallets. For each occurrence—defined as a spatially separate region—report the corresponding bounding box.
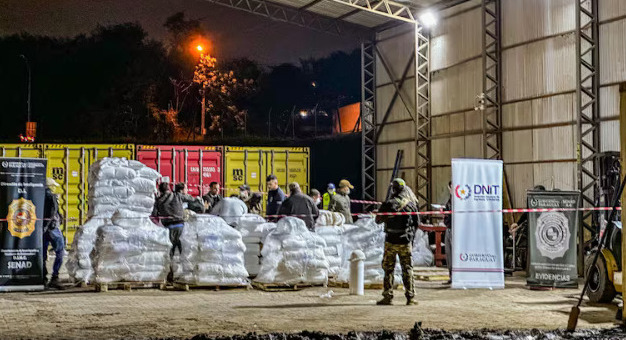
[0,258,617,339]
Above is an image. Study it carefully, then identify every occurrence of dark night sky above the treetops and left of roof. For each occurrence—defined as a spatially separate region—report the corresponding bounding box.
[0,0,360,65]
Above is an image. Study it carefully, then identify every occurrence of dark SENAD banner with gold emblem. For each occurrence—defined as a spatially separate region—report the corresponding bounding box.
[0,158,47,291]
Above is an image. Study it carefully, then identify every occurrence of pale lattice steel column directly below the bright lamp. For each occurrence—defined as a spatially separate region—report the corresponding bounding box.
[415,24,432,210]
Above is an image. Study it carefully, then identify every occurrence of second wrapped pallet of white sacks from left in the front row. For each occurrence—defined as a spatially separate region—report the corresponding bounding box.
[178,215,249,286]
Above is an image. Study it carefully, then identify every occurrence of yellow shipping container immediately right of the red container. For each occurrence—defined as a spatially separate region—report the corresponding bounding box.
[222,146,310,209]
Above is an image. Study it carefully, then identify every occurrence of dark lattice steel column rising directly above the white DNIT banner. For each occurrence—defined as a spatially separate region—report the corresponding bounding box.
[480,0,502,159]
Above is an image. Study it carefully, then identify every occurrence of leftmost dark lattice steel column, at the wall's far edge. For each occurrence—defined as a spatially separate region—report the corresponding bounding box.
[360,42,376,201]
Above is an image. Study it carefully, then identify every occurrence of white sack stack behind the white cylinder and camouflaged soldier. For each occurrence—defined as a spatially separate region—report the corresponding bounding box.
[337,215,402,284]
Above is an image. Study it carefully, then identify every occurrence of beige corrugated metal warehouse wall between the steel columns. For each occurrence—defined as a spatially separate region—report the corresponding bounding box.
[377,0,626,207]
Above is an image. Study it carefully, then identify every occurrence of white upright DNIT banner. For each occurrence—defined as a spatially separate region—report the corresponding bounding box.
[452,159,504,289]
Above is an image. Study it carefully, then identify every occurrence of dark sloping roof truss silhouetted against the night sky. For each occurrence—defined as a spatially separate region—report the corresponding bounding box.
[205,0,369,35]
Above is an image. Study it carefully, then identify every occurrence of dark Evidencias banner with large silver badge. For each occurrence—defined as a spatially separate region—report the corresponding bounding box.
[527,191,580,288]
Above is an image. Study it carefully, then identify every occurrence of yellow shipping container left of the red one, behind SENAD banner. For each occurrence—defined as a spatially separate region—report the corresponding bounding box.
[0,144,135,247]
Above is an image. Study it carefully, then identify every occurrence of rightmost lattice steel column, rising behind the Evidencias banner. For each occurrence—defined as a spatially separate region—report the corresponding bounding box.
[576,0,600,239]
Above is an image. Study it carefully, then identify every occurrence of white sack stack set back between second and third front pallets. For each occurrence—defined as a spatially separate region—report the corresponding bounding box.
[237,214,276,276]
